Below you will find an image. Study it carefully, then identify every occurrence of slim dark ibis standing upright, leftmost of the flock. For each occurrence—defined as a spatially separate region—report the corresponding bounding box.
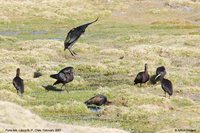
[13,68,24,97]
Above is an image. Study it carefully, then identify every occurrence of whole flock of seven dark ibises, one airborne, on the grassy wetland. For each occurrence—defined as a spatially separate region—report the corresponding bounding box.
[13,18,173,109]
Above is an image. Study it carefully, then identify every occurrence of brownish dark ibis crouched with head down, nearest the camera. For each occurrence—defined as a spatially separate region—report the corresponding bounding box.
[84,95,111,106]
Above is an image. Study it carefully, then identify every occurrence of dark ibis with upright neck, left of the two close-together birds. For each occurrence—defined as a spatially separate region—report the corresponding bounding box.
[134,63,149,86]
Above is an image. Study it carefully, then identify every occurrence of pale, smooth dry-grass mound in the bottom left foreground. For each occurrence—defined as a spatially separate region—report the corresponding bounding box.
[0,101,128,133]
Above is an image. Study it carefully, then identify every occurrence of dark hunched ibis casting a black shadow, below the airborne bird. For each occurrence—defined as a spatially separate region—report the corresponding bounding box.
[50,67,74,89]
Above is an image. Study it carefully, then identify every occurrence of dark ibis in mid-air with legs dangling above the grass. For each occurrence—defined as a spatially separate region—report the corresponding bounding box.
[64,18,99,56]
